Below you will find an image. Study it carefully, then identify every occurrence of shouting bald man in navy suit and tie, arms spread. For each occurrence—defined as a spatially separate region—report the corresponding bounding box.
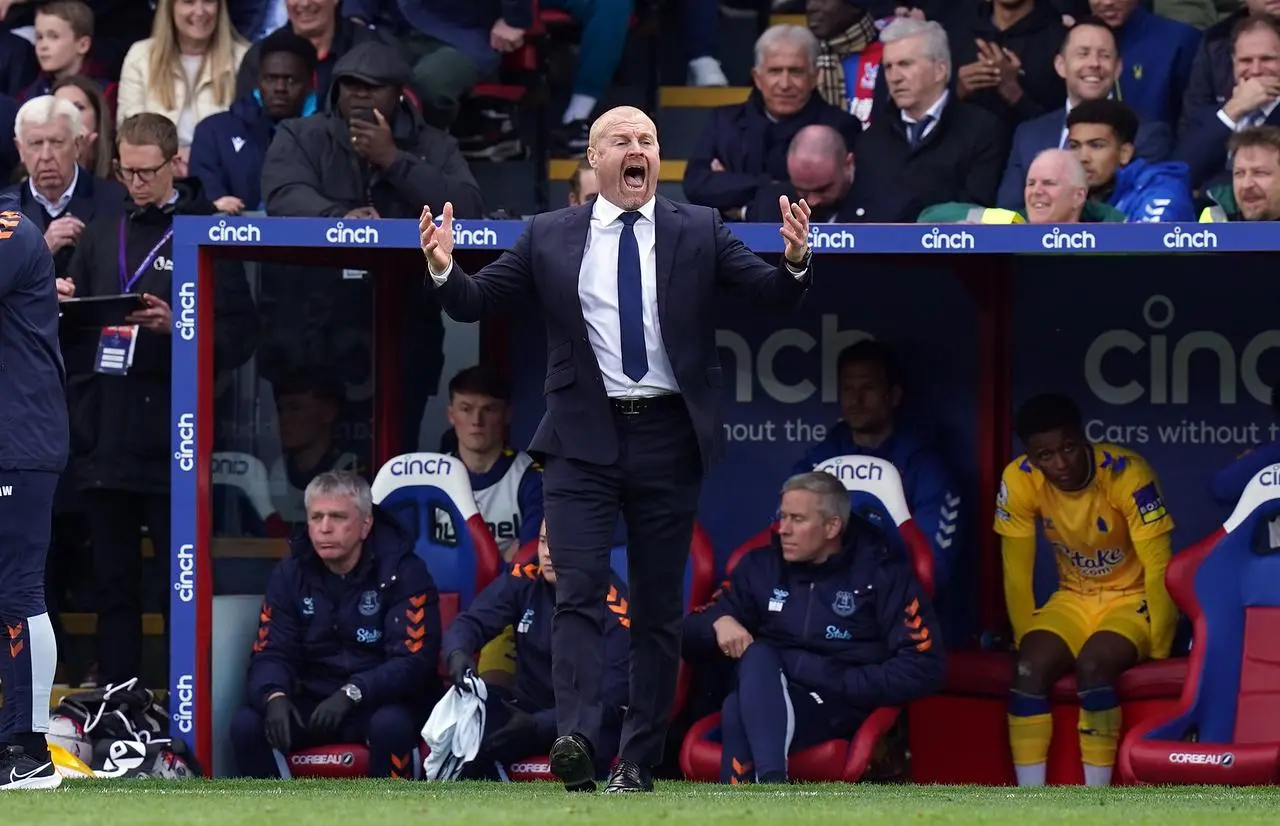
[420,106,812,791]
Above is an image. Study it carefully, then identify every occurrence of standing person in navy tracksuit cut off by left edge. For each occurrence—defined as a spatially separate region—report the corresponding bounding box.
[0,197,70,790]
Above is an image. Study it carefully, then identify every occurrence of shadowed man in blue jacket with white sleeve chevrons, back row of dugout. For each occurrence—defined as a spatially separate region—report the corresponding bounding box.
[792,339,968,601]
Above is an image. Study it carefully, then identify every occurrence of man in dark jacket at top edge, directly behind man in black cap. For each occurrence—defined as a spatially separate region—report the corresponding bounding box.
[232,0,399,97]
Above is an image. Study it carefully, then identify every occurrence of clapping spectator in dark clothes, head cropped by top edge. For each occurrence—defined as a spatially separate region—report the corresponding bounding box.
[952,0,1066,128]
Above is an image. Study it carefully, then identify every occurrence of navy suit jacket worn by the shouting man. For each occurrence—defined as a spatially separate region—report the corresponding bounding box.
[428,196,813,470]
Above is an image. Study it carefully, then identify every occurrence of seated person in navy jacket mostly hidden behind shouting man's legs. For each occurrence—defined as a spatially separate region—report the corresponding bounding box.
[443,521,631,777]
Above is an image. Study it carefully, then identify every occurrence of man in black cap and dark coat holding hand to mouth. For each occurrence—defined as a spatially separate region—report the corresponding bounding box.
[262,44,484,218]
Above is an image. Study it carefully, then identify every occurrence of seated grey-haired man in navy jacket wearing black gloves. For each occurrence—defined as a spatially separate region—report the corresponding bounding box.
[230,470,442,779]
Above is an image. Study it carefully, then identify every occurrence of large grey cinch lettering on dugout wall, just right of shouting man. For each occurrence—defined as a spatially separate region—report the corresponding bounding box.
[716,312,872,405]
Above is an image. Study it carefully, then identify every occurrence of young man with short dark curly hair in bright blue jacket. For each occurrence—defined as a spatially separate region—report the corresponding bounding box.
[1066,99,1196,223]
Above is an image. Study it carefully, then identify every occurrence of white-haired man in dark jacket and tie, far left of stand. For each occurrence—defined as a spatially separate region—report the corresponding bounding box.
[0,95,127,278]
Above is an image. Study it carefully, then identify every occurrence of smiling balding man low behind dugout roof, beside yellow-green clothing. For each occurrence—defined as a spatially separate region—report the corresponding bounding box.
[919,149,1125,224]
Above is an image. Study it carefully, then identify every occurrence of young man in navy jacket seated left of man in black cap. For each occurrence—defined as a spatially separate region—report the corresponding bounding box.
[188,27,316,215]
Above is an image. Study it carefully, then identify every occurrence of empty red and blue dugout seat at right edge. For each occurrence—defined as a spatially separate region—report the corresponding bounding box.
[1117,465,1280,785]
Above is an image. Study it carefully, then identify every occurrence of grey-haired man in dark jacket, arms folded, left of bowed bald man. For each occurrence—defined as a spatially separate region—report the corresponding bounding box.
[684,26,863,220]
